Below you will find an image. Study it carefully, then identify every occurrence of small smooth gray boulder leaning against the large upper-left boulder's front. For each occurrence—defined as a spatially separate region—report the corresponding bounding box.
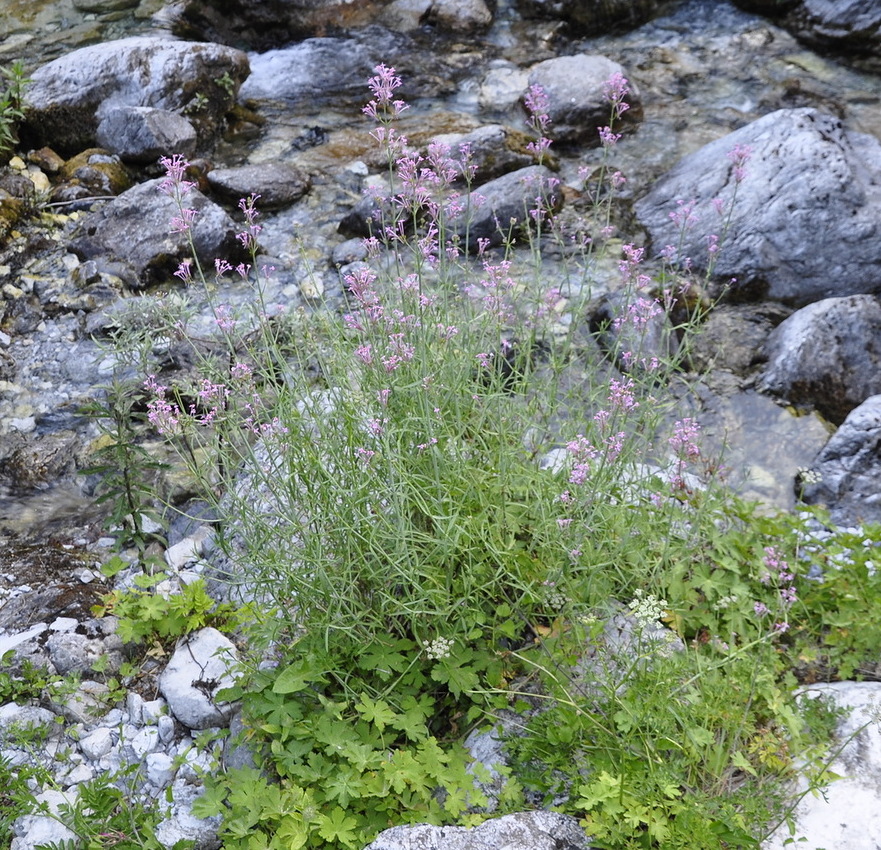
[96,106,197,163]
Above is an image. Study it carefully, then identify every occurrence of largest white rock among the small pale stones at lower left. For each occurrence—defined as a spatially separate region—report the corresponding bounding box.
[159,628,238,729]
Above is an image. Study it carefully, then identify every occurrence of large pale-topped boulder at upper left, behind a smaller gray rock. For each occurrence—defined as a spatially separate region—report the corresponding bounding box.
[21,36,248,151]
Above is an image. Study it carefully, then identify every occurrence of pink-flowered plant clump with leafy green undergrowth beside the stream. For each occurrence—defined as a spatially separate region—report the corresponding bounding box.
[74,66,881,850]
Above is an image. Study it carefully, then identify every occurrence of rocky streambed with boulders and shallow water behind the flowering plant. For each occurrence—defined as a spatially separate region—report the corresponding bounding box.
[0,0,881,850]
